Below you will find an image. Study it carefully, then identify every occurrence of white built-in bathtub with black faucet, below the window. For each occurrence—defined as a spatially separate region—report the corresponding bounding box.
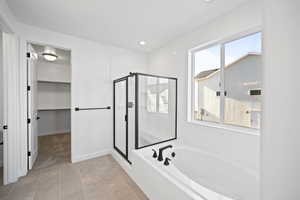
[133,143,259,200]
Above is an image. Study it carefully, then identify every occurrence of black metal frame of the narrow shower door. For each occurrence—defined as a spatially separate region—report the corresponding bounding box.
[113,76,131,164]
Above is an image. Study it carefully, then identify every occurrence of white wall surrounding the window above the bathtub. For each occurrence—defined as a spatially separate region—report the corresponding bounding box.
[148,1,262,172]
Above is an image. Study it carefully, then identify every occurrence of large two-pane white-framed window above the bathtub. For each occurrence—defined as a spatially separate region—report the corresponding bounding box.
[191,32,262,129]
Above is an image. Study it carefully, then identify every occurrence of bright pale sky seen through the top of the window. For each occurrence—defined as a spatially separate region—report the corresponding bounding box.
[195,32,262,75]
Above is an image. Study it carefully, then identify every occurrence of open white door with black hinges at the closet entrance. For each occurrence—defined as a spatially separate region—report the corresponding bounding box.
[27,44,38,170]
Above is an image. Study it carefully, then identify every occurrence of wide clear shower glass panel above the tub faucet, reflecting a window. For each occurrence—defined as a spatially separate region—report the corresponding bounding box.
[136,74,177,148]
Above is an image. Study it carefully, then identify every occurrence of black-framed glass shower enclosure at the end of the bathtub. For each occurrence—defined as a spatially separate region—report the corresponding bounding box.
[113,73,177,163]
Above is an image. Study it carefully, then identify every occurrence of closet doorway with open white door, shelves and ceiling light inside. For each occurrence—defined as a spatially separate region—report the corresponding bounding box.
[27,43,71,170]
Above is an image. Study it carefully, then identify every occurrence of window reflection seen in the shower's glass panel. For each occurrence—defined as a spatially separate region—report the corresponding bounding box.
[147,77,169,113]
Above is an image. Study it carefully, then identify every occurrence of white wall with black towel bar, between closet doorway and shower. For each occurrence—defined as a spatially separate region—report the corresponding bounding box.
[19,22,146,161]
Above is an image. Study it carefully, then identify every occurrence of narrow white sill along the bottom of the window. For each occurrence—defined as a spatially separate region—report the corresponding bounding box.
[188,120,260,136]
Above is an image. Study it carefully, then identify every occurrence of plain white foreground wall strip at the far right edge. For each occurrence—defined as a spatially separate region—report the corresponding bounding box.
[261,0,300,200]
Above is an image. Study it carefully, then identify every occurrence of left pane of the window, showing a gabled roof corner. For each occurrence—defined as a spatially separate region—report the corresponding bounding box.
[194,45,221,122]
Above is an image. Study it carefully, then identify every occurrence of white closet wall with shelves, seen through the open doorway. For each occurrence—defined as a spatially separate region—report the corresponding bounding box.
[34,45,71,136]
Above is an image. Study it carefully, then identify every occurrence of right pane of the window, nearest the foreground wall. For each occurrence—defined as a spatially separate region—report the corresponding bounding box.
[224,33,262,129]
